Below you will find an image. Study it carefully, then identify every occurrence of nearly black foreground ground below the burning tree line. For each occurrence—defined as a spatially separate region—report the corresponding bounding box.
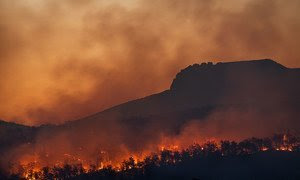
[4,151,300,180]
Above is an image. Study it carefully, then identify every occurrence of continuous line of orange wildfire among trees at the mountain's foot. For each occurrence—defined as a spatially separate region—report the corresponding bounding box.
[6,134,300,179]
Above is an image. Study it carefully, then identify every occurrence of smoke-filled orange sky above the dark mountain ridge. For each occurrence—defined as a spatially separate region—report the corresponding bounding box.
[0,0,300,125]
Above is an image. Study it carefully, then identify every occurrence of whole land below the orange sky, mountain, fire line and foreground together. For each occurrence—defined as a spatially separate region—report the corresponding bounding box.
[0,59,300,179]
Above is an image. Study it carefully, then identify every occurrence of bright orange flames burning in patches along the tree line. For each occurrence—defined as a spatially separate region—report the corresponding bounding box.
[6,134,300,179]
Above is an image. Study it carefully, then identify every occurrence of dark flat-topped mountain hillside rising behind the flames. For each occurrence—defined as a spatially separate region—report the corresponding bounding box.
[0,59,300,158]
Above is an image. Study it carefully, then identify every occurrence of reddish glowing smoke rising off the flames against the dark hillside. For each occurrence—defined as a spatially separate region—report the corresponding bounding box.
[0,101,300,172]
